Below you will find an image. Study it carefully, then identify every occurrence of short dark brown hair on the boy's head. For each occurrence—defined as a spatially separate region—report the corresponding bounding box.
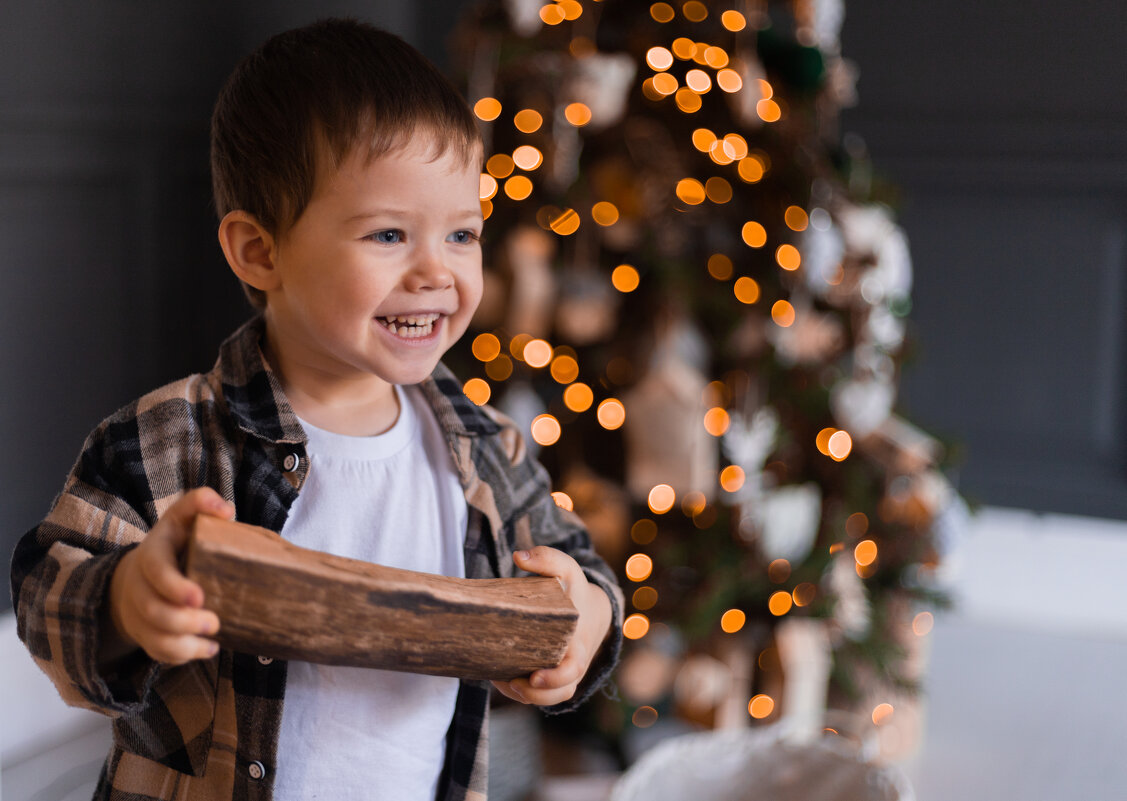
[211,19,481,309]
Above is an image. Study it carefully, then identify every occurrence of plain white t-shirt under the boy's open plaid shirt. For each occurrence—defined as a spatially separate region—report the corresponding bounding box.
[274,386,468,801]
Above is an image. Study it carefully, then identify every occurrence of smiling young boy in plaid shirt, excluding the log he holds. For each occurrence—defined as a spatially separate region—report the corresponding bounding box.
[12,20,622,800]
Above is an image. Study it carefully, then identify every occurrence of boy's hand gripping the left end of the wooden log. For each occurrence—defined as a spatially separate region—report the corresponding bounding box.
[100,488,234,665]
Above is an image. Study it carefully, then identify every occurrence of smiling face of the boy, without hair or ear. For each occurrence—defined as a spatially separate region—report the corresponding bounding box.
[266,136,482,394]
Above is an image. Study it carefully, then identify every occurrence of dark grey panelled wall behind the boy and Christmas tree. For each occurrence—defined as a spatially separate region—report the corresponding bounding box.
[0,0,1127,609]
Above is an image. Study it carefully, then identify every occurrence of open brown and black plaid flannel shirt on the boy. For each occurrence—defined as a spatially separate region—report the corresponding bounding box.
[12,319,623,801]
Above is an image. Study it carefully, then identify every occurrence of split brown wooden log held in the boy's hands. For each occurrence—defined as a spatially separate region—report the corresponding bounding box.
[184,515,578,680]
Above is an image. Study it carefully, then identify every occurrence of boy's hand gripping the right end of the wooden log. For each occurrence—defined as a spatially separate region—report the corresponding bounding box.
[492,545,611,706]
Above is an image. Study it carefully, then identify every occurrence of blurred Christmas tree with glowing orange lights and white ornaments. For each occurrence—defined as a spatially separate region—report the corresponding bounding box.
[454,0,955,766]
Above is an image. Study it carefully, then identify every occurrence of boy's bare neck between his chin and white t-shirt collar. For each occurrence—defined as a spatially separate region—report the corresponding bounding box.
[263,327,399,437]
